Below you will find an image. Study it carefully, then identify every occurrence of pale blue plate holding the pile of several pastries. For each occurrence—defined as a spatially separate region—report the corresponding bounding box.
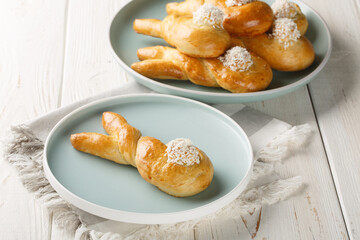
[109,0,332,103]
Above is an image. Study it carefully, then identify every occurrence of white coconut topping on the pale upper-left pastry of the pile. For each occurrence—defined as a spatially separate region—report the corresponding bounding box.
[193,3,224,28]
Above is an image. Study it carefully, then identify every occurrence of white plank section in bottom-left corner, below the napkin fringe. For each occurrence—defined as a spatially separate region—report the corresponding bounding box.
[0,161,51,240]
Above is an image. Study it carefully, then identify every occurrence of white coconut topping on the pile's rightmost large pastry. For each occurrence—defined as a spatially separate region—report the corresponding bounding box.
[272,18,301,49]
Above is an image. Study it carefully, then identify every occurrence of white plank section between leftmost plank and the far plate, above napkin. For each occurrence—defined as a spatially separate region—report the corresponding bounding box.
[61,0,126,105]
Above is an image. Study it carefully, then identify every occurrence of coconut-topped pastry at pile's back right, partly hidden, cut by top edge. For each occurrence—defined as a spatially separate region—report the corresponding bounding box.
[271,0,309,36]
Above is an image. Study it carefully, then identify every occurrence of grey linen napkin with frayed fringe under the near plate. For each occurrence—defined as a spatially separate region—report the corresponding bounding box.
[4,82,311,239]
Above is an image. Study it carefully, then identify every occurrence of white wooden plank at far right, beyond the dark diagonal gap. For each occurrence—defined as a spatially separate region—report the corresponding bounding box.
[309,0,360,239]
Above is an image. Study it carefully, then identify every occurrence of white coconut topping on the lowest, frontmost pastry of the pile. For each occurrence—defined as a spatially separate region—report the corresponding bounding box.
[218,46,253,72]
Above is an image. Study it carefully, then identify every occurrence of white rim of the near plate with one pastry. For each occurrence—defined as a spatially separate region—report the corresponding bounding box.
[43,93,254,224]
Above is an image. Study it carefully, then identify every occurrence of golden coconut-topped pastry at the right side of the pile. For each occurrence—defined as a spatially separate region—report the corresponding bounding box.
[240,18,315,71]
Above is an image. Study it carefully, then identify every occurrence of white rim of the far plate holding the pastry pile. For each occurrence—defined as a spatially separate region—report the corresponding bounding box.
[107,0,333,103]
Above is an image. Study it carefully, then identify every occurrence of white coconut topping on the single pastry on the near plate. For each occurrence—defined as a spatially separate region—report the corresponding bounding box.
[166,138,200,166]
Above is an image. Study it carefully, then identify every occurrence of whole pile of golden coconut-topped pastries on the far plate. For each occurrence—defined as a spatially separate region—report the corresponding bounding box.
[131,0,315,93]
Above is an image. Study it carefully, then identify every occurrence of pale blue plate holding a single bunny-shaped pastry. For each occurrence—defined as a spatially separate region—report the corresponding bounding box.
[44,94,252,224]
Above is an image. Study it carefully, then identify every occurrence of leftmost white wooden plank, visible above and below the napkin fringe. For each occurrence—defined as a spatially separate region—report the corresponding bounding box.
[0,0,65,239]
